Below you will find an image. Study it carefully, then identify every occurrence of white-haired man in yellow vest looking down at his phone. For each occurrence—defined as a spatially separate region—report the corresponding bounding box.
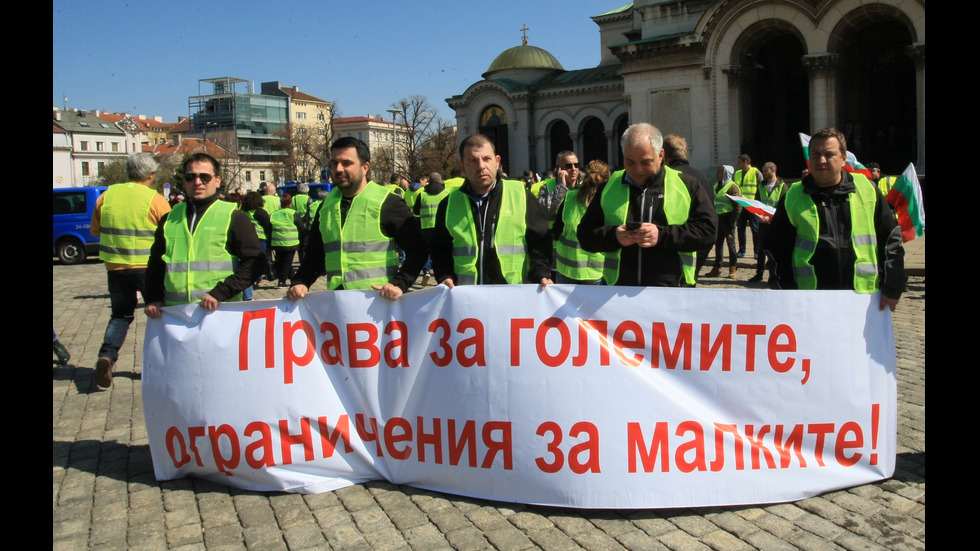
[577,123,718,287]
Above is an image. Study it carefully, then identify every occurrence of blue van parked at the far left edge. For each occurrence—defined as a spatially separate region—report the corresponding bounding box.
[51,186,109,264]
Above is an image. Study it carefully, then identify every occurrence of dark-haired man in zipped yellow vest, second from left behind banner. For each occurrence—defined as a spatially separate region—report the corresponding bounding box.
[286,136,428,301]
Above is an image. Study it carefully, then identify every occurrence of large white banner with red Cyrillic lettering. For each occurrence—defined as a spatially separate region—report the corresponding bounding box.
[143,285,897,508]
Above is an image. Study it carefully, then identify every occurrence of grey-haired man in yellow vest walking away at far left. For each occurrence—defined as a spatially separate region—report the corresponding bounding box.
[91,153,170,388]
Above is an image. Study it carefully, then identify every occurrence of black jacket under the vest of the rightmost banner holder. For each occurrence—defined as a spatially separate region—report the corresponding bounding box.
[763,171,908,299]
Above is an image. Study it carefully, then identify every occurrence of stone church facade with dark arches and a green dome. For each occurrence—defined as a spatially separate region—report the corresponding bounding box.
[447,0,926,179]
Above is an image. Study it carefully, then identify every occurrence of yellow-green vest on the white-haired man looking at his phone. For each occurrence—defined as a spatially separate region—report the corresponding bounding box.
[600,166,697,285]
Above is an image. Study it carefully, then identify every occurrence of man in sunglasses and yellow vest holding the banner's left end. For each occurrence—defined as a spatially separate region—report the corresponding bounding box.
[144,153,266,318]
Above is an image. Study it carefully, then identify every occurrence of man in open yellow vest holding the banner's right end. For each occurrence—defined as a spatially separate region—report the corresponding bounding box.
[766,128,908,312]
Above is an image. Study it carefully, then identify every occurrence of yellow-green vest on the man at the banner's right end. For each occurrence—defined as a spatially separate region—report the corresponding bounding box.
[786,173,878,293]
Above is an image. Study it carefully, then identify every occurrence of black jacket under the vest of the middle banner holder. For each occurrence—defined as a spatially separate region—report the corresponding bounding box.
[429,180,552,285]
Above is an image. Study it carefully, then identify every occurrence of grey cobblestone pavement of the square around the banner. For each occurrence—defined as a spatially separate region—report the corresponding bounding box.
[52,245,926,551]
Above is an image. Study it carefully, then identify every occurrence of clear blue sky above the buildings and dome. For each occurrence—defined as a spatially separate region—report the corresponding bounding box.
[51,0,626,122]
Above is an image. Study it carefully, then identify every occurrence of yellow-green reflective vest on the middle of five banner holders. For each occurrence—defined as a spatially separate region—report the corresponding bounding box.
[446,180,528,285]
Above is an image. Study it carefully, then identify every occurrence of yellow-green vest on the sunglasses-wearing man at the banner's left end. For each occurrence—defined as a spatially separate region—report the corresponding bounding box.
[163,201,242,306]
